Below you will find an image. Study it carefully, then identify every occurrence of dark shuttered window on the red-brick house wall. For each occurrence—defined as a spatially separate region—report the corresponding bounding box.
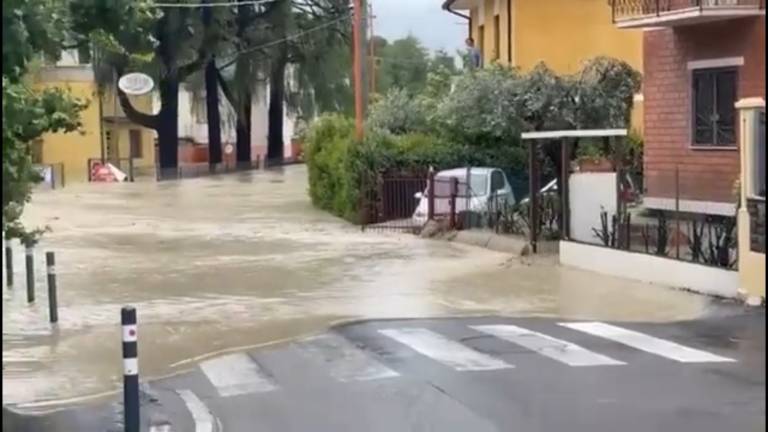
[693,68,737,147]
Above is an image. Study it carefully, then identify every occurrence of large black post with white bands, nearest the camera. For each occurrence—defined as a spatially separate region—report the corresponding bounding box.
[120,306,139,432]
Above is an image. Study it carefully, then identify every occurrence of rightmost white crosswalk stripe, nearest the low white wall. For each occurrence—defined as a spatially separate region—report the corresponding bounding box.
[558,322,736,363]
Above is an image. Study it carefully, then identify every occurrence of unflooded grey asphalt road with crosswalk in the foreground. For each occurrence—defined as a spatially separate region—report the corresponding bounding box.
[3,312,765,432]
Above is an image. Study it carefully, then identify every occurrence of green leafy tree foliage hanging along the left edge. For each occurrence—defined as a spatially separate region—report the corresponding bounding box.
[2,0,86,243]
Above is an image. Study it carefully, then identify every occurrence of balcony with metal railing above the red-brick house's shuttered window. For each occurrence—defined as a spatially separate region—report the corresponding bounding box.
[609,0,766,28]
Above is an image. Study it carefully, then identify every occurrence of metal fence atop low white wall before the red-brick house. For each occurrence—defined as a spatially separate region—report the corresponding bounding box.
[569,167,738,269]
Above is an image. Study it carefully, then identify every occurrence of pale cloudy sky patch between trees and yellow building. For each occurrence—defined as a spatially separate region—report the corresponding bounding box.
[372,0,467,54]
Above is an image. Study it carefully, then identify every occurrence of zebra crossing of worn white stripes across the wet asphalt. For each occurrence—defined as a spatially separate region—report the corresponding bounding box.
[164,322,737,432]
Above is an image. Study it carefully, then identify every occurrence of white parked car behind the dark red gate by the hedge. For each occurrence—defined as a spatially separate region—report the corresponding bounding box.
[412,167,516,224]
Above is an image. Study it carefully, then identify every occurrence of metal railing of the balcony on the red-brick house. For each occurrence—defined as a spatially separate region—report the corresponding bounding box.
[610,0,765,23]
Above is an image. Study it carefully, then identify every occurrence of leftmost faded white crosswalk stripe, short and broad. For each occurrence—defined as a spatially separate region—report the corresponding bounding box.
[200,353,277,397]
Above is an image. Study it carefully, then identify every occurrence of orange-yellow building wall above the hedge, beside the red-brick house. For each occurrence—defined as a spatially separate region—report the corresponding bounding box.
[470,0,643,132]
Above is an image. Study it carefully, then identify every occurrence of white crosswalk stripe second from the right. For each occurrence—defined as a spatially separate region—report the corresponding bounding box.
[470,325,625,366]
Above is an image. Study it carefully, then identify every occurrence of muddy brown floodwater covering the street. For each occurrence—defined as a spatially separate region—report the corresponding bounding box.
[3,166,728,410]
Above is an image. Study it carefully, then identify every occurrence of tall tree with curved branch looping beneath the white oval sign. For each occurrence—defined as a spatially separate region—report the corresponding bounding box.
[70,0,213,177]
